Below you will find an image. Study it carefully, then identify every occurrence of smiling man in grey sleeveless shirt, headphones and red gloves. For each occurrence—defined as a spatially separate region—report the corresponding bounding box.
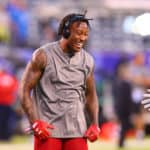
[20,14,100,150]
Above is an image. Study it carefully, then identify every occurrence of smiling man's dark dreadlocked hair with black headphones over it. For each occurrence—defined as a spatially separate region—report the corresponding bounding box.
[58,13,92,38]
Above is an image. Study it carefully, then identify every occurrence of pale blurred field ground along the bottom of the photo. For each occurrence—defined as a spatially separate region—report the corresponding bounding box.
[0,136,150,150]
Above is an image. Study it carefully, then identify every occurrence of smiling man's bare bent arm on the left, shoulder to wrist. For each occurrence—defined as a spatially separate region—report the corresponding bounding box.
[19,49,46,124]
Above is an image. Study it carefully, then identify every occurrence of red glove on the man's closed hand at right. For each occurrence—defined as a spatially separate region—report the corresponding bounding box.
[85,124,100,142]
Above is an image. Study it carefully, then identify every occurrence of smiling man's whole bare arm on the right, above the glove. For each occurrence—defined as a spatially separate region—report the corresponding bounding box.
[86,69,99,125]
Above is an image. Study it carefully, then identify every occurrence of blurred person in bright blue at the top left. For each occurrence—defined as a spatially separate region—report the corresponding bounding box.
[7,0,36,47]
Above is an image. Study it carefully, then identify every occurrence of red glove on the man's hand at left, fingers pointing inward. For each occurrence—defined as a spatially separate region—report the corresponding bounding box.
[32,120,54,140]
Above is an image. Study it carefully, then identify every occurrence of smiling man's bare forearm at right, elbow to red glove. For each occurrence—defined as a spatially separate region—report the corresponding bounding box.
[86,95,99,125]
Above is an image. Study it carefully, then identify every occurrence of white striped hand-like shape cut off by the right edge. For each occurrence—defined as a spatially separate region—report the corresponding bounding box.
[141,89,150,111]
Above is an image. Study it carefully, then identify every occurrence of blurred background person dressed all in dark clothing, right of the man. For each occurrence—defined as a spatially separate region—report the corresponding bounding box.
[112,58,132,147]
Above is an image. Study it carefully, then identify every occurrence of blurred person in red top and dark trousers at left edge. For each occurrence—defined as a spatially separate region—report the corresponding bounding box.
[0,71,18,140]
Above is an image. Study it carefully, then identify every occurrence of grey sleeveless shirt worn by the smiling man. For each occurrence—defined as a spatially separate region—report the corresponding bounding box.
[32,42,94,138]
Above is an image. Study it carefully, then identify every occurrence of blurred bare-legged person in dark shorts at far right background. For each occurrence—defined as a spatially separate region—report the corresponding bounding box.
[128,52,150,140]
